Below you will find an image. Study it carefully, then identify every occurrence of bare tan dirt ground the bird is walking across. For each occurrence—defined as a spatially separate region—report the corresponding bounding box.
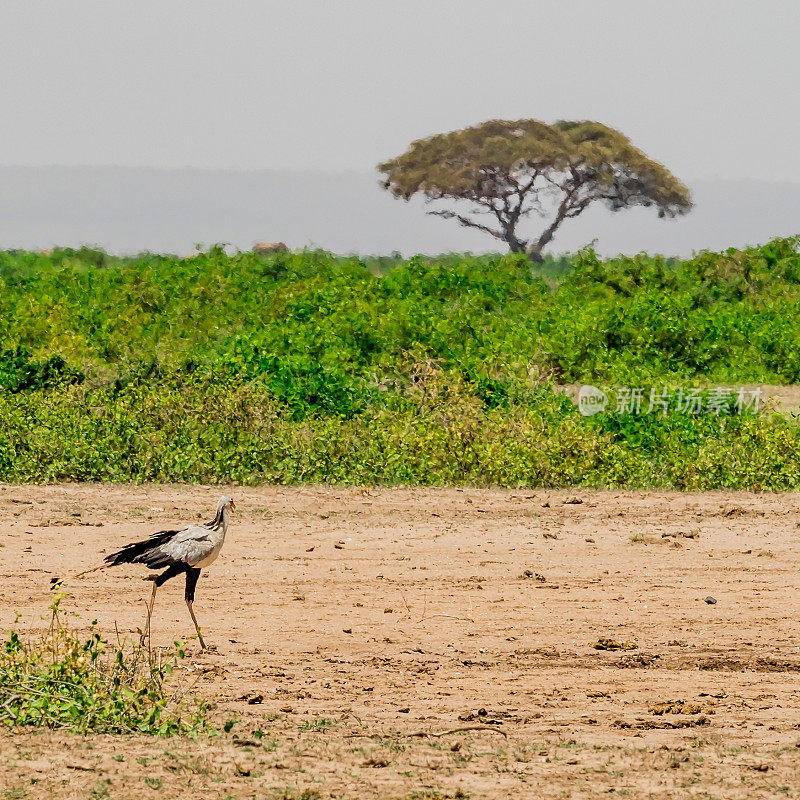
[0,485,800,800]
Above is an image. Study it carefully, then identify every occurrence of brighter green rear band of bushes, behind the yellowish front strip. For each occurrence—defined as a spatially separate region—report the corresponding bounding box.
[0,239,800,390]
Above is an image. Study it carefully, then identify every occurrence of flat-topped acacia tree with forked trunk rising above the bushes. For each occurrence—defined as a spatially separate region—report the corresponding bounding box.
[378,119,692,261]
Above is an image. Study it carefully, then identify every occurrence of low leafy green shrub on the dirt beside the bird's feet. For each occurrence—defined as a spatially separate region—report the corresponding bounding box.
[0,595,206,736]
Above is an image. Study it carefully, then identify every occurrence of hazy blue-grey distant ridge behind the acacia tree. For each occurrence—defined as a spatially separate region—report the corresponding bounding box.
[0,166,800,255]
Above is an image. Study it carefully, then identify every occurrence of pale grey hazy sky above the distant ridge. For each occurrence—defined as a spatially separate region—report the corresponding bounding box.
[0,0,800,182]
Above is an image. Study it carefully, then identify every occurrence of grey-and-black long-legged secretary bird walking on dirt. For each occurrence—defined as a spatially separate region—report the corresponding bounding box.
[50,495,236,650]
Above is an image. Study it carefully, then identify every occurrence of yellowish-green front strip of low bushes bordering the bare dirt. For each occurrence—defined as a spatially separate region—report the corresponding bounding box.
[0,368,800,489]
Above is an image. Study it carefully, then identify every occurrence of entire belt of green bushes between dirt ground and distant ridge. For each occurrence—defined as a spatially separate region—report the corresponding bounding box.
[0,239,800,489]
